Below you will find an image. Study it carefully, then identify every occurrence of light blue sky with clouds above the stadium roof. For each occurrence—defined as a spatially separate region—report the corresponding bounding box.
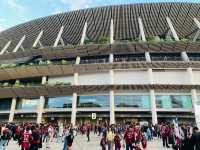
[0,0,200,31]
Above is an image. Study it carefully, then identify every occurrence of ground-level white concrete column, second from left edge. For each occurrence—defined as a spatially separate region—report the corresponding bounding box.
[37,96,45,124]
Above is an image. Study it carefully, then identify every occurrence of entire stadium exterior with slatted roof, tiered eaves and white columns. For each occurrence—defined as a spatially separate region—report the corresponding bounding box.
[0,3,200,126]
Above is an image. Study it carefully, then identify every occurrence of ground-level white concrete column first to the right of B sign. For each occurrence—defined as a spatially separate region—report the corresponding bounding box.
[110,90,115,124]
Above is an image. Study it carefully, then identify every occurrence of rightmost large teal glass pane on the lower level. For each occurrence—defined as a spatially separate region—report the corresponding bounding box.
[156,95,192,108]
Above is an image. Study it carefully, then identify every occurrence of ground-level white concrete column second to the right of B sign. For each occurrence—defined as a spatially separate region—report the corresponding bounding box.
[150,89,158,125]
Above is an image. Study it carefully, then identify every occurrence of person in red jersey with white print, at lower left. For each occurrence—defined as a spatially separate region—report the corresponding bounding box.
[22,127,31,150]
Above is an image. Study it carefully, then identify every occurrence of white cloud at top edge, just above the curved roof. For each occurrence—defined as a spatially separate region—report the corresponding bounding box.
[61,0,94,10]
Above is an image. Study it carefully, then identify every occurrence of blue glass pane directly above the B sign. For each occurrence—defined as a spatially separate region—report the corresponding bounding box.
[77,95,110,108]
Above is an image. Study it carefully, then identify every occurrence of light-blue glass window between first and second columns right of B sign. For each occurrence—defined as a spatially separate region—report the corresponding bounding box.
[115,95,150,108]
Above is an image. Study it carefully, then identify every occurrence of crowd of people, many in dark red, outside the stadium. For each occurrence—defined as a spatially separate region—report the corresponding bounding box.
[0,122,200,150]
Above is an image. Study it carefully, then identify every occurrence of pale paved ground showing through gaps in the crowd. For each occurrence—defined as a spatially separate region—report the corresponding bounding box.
[6,134,172,150]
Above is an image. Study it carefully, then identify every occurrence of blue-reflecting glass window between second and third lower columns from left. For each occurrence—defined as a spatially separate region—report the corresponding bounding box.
[45,96,72,108]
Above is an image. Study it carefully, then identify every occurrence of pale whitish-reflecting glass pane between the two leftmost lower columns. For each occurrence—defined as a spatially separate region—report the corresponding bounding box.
[16,98,40,110]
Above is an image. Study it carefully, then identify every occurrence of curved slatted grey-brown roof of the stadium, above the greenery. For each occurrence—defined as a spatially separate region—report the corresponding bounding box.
[0,2,200,51]
